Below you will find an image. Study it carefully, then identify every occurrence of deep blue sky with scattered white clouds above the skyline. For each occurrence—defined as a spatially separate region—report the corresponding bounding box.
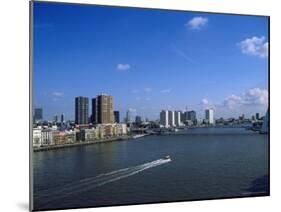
[34,2,268,119]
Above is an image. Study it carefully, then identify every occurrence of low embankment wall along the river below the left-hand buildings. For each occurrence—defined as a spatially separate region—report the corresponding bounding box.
[33,135,134,152]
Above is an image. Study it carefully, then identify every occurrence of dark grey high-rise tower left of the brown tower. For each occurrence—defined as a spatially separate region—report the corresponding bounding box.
[75,96,89,124]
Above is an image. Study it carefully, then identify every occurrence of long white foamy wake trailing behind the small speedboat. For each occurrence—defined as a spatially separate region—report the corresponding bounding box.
[34,158,171,205]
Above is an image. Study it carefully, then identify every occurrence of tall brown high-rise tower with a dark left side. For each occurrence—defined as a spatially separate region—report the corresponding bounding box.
[92,94,115,124]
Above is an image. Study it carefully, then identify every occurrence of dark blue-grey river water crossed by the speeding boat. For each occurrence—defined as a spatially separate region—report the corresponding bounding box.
[33,128,269,210]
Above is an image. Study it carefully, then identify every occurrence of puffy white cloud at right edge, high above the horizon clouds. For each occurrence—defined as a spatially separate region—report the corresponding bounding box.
[238,36,268,58]
